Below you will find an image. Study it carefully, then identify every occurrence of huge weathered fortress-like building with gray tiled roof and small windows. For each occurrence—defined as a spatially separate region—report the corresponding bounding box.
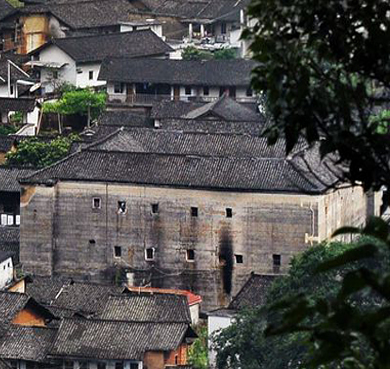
[21,128,380,309]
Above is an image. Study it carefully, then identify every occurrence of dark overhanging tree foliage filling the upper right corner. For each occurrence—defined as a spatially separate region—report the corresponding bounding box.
[244,0,390,189]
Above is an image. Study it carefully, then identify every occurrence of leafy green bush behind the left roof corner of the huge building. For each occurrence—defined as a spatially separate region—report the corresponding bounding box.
[6,135,77,168]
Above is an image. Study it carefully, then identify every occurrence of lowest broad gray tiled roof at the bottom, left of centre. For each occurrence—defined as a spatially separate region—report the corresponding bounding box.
[51,319,188,360]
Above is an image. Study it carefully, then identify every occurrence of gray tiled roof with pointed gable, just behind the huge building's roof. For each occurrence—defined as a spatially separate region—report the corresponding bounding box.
[151,95,264,123]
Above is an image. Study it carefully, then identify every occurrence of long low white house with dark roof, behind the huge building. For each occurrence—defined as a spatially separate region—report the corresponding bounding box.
[99,58,257,107]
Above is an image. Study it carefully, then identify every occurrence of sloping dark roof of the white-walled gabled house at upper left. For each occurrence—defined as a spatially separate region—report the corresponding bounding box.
[32,30,172,63]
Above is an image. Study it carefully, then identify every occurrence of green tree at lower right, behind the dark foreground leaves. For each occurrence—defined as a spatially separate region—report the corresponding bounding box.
[215,238,390,369]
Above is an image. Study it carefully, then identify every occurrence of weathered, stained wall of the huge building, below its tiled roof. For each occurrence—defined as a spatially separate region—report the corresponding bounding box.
[21,182,374,309]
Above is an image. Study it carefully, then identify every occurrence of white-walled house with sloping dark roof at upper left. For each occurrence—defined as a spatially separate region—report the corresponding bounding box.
[26,30,172,94]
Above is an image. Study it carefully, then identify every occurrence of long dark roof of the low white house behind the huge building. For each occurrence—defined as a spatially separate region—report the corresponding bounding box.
[99,58,256,86]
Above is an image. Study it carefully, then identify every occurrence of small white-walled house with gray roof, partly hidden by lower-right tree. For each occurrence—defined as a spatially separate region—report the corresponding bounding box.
[207,273,275,368]
